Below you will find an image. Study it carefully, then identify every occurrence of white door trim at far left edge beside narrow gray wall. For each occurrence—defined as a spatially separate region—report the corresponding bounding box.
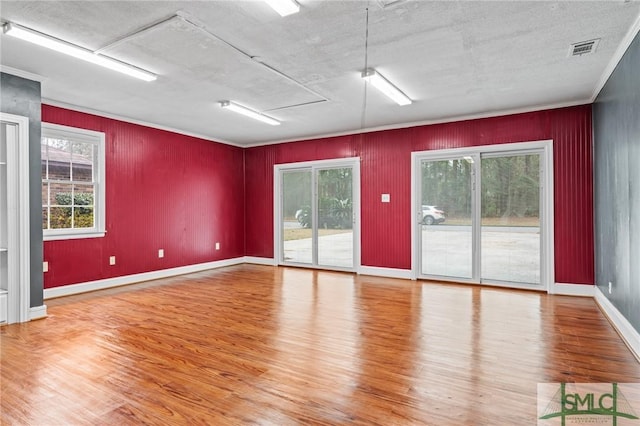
[0,112,31,324]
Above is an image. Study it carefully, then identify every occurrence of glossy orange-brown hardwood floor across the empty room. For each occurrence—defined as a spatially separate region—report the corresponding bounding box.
[0,265,640,425]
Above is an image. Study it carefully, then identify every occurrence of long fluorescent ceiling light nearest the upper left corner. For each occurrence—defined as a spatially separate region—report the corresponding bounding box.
[2,22,157,81]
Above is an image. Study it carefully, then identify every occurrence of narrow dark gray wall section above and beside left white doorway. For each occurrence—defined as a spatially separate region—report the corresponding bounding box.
[0,73,43,307]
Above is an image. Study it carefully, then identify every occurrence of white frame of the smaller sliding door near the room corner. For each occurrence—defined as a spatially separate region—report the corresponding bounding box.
[273,157,361,273]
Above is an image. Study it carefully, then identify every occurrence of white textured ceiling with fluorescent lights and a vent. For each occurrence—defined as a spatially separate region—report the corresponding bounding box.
[0,0,640,146]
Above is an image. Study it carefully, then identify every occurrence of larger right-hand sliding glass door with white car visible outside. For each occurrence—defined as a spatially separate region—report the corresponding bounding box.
[412,142,552,288]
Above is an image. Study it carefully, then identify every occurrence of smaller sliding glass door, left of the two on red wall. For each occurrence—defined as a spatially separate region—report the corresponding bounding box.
[275,159,359,271]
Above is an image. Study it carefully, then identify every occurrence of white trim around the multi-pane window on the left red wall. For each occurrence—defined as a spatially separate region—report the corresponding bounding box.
[42,122,106,241]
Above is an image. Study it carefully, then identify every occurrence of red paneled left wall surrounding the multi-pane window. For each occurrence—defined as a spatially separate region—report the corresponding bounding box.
[42,105,244,288]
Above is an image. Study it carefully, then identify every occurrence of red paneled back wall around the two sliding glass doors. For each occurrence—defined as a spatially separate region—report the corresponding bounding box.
[245,105,594,284]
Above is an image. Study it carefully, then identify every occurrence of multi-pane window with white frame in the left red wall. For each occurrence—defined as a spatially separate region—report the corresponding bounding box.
[41,123,105,240]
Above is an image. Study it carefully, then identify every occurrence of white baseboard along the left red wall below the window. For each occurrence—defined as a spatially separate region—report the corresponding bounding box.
[44,257,244,300]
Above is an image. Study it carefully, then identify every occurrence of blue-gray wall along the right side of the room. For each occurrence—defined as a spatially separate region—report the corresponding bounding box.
[593,35,640,332]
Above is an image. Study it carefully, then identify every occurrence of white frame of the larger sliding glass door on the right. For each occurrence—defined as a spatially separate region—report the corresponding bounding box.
[411,140,555,292]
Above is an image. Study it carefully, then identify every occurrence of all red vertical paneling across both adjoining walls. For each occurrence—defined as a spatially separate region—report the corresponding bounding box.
[43,106,594,288]
